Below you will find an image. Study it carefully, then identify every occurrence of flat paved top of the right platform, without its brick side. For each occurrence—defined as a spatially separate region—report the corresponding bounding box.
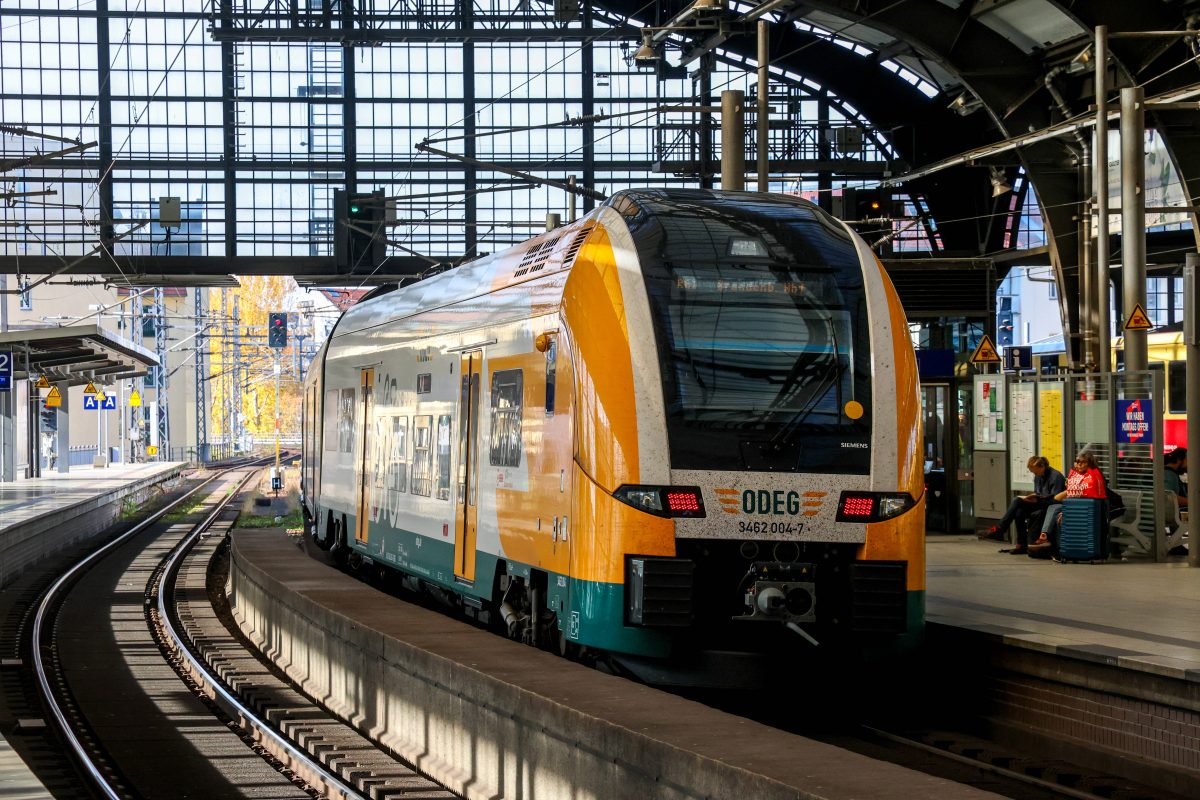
[926,535,1200,682]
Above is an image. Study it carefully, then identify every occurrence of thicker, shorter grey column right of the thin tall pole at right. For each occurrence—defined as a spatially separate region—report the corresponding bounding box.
[1121,86,1147,372]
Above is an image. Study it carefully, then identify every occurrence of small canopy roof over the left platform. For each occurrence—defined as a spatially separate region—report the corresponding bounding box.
[0,325,158,386]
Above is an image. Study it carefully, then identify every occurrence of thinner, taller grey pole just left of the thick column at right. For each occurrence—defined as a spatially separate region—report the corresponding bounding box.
[1092,25,1112,372]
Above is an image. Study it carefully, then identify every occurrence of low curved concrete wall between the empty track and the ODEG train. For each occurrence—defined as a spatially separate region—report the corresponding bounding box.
[228,531,995,800]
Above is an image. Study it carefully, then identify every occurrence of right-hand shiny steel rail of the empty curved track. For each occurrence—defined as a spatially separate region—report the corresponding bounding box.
[157,473,367,800]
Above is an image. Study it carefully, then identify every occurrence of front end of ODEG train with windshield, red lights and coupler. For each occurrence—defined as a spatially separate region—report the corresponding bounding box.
[590,191,925,681]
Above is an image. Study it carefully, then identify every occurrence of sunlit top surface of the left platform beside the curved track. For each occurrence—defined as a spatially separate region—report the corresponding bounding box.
[0,462,184,533]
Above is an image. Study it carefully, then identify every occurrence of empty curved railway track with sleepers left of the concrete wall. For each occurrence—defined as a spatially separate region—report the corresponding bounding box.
[28,455,456,800]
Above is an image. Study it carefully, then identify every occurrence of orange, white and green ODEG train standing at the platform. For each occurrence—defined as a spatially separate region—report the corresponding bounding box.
[301,190,925,685]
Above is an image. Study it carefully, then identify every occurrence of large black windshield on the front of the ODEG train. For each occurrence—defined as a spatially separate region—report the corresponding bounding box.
[619,190,871,474]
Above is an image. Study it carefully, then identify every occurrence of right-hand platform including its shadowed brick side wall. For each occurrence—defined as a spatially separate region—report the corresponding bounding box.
[926,535,1200,796]
